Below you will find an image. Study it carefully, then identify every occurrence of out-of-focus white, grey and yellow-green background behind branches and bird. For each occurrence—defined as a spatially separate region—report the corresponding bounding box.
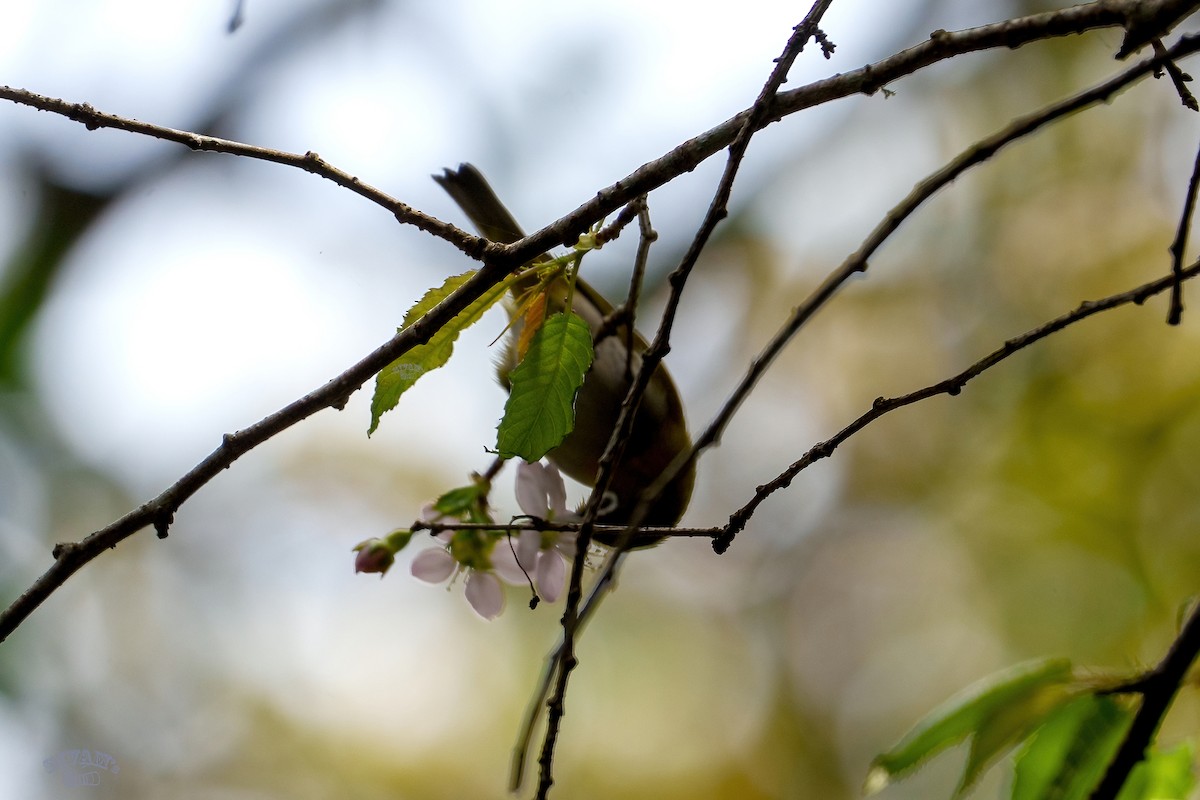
[0,0,1200,800]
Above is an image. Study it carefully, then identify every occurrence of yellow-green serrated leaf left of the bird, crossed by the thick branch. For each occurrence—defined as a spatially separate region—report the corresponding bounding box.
[367,270,511,435]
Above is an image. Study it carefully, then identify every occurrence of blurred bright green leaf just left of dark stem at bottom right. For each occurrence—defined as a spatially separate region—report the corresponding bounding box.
[1013,693,1133,800]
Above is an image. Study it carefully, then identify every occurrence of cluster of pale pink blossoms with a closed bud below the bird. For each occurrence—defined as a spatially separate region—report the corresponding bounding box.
[354,462,580,619]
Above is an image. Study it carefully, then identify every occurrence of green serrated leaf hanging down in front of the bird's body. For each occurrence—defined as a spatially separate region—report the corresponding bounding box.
[496,312,593,462]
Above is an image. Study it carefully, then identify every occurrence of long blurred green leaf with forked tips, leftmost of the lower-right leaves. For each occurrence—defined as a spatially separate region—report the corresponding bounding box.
[864,658,1079,795]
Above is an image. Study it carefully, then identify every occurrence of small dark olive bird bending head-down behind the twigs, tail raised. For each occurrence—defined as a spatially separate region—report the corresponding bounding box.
[433,164,696,543]
